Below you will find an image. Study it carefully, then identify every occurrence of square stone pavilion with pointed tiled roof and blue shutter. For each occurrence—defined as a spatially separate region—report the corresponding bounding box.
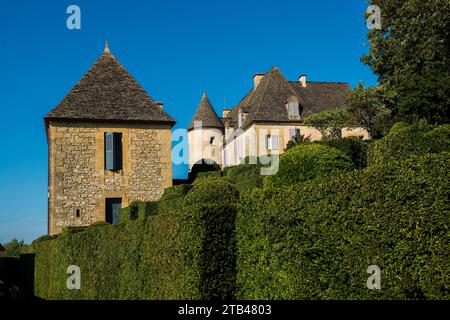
[44,44,175,235]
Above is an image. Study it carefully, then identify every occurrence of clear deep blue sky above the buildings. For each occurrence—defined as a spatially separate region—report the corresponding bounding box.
[0,0,376,242]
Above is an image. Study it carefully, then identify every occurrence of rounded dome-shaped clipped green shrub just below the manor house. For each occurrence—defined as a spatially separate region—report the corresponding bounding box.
[265,144,354,186]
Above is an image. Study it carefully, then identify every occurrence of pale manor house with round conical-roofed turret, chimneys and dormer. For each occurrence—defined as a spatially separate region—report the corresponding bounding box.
[188,67,370,169]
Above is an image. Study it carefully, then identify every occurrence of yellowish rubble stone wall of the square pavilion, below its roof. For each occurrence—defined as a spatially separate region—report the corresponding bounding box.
[48,122,172,234]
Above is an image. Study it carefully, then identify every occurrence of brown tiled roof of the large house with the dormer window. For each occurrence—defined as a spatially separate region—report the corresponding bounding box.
[226,67,350,128]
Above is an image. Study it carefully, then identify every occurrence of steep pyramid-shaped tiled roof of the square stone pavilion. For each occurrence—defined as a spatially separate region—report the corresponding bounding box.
[45,46,175,125]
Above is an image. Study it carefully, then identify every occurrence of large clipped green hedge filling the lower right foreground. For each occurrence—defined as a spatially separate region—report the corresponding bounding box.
[236,153,450,299]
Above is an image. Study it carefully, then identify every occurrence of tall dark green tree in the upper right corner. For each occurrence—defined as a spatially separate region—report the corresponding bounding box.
[362,0,450,123]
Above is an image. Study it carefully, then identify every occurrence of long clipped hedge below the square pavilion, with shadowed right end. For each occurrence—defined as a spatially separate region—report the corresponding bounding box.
[31,181,238,299]
